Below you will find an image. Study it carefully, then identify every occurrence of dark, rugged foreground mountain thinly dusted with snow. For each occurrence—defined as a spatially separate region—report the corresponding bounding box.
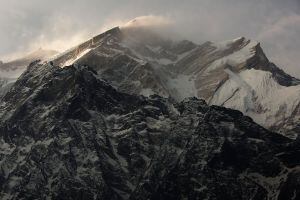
[0,63,300,200]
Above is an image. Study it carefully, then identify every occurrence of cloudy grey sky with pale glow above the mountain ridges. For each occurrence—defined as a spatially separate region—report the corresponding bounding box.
[0,0,300,78]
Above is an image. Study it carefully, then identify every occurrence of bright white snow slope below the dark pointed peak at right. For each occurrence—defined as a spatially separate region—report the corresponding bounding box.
[211,69,300,137]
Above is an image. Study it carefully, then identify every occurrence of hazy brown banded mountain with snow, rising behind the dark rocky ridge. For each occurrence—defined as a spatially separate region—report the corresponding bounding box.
[53,27,300,137]
